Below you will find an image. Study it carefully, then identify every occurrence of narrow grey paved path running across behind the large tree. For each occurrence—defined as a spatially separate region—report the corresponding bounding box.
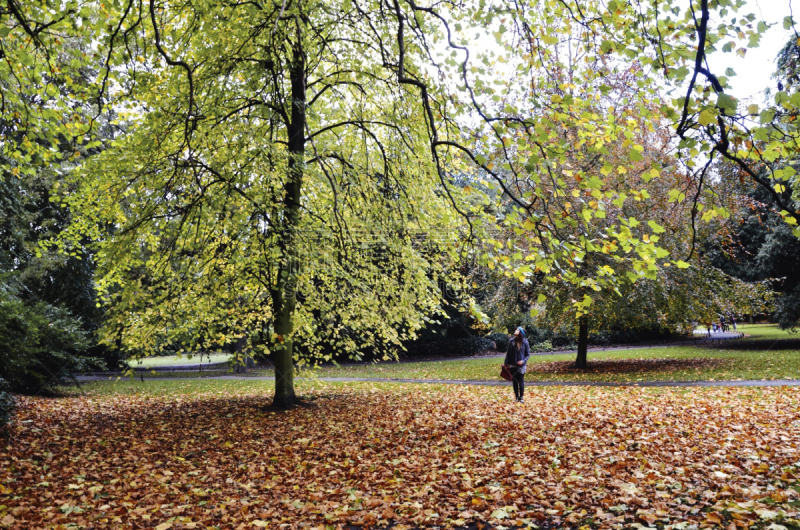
[77,375,800,387]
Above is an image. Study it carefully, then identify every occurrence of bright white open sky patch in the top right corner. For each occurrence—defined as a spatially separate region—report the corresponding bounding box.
[720,0,800,103]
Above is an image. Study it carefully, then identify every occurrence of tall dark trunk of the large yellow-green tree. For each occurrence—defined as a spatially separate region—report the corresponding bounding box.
[272,43,306,408]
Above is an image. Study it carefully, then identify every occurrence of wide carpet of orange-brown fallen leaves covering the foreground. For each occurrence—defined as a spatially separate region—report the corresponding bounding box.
[0,385,800,530]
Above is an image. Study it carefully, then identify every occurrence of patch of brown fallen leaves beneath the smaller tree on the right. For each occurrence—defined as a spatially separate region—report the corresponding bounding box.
[528,357,731,374]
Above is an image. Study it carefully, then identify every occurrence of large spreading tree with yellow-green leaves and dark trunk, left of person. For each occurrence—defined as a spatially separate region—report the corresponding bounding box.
[51,0,476,406]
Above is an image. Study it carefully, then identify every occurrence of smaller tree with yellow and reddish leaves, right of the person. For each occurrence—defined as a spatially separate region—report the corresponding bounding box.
[450,13,687,368]
